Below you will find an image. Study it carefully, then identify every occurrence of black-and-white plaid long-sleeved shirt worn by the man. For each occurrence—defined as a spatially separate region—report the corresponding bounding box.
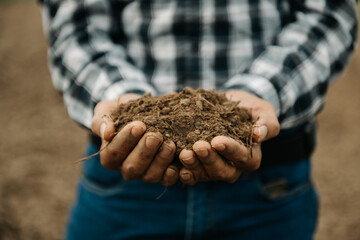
[42,0,357,128]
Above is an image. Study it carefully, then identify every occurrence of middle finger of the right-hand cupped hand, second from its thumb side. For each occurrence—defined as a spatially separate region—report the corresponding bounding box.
[193,141,241,182]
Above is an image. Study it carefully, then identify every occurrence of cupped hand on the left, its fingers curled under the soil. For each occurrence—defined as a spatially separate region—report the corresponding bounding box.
[91,94,179,186]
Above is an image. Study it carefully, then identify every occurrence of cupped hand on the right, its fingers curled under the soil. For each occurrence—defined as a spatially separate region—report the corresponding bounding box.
[179,90,280,185]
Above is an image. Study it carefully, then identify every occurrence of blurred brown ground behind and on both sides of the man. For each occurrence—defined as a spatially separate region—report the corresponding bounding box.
[0,0,360,240]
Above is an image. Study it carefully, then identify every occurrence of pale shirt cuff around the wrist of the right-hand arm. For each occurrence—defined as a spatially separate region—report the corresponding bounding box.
[224,74,281,117]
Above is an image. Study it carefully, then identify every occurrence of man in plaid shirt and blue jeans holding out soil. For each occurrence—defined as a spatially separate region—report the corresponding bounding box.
[43,0,357,239]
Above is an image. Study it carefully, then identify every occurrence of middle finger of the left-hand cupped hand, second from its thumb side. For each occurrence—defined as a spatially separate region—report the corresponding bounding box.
[120,132,162,180]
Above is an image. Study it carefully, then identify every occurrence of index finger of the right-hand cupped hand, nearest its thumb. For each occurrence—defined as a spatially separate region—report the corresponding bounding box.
[211,136,261,171]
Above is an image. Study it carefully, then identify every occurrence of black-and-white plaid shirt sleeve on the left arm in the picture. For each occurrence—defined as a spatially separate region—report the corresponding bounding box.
[42,0,157,128]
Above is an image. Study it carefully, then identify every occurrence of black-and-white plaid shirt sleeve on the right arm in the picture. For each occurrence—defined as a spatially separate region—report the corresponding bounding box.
[225,0,357,128]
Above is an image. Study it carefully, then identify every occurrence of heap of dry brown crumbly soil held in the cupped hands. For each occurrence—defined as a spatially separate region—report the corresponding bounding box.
[110,87,254,155]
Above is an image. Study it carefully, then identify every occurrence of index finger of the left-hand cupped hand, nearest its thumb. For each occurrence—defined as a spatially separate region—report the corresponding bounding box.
[100,121,146,170]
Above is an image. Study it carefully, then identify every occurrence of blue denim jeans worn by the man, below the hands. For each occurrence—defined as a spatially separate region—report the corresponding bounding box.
[65,144,318,240]
